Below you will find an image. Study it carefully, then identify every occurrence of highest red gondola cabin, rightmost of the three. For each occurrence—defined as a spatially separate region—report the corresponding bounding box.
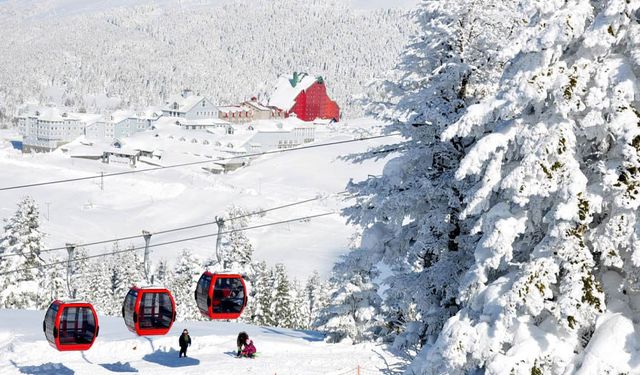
[195,272,247,319]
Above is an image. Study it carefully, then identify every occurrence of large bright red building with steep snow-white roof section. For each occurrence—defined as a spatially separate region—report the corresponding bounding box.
[269,73,340,121]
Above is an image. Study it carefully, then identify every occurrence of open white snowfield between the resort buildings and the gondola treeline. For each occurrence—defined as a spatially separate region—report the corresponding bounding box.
[0,119,395,279]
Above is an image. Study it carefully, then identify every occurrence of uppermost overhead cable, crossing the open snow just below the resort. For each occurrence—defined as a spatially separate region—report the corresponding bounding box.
[0,133,400,191]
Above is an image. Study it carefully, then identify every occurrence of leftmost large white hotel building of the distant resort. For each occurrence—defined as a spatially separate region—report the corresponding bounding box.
[17,107,101,152]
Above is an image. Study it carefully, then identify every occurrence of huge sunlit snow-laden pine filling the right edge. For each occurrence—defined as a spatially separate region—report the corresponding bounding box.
[414,0,640,374]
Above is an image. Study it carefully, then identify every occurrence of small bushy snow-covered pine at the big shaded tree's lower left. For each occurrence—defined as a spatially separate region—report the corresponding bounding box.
[318,274,382,342]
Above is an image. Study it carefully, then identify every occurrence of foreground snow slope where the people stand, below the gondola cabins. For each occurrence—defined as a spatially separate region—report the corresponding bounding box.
[0,310,399,375]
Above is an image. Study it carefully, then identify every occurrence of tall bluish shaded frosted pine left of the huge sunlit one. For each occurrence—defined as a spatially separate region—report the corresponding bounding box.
[342,0,527,350]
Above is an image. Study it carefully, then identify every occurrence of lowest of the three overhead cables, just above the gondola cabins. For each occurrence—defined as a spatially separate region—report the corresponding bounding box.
[0,212,336,276]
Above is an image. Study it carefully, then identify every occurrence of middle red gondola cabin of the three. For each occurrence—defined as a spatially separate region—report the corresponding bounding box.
[122,286,176,336]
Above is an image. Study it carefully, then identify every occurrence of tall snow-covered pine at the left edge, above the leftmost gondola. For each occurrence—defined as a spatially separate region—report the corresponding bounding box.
[0,197,47,309]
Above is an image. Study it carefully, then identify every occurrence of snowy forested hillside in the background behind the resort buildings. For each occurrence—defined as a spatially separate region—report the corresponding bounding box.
[0,0,413,117]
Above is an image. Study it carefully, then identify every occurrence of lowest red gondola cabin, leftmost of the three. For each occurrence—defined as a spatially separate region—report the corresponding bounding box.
[42,300,100,351]
